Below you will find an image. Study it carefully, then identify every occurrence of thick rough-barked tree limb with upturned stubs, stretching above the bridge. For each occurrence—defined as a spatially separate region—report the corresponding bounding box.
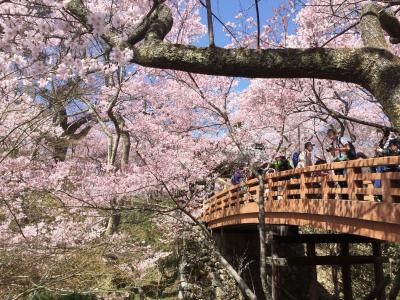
[65,0,400,128]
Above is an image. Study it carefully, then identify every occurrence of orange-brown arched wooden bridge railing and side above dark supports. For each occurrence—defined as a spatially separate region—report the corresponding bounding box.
[203,157,400,243]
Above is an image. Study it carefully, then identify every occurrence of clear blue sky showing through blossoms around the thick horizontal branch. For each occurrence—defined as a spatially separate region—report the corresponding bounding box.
[196,0,294,91]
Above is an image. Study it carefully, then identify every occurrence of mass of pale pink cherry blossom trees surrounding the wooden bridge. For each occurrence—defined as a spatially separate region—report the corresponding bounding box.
[0,0,400,299]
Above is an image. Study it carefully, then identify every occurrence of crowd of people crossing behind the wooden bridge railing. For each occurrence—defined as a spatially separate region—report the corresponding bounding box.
[219,128,400,198]
